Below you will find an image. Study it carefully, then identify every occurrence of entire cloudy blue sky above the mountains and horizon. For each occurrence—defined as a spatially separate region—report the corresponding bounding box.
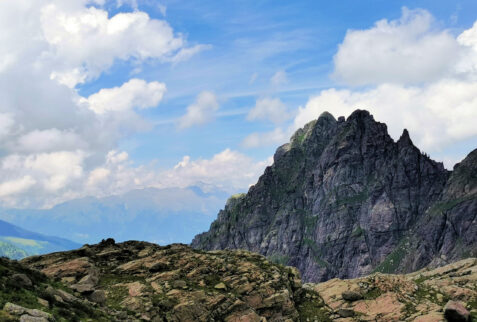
[0,0,477,208]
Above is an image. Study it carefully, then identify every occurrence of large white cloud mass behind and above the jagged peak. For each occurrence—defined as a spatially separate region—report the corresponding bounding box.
[294,9,477,168]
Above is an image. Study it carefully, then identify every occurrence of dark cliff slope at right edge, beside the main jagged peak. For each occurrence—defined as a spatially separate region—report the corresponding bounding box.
[399,149,477,271]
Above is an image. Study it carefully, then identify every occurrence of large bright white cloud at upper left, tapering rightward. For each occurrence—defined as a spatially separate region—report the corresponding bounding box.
[41,3,203,87]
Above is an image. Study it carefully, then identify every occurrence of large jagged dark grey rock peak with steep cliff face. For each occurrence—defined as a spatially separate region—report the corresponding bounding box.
[192,110,477,282]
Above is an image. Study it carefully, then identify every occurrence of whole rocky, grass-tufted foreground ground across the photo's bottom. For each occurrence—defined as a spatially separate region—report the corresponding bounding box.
[0,240,477,322]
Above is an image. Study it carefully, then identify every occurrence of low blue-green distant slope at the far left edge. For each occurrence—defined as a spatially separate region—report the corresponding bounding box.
[0,220,81,259]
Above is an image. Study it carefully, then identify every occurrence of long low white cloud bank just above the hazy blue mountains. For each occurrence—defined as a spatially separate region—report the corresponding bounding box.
[76,149,272,201]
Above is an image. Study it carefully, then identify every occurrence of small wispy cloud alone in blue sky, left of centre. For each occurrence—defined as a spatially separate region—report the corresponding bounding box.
[179,91,219,129]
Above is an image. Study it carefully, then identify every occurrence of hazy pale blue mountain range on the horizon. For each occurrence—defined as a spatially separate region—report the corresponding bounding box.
[0,187,228,244]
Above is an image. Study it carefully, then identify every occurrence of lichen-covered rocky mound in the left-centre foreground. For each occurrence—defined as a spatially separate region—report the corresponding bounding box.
[22,241,328,321]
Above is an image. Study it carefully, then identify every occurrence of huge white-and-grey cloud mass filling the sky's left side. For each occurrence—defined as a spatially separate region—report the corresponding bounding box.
[0,0,205,207]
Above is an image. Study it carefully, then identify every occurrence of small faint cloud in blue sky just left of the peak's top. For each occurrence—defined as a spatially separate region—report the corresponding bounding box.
[247,97,291,123]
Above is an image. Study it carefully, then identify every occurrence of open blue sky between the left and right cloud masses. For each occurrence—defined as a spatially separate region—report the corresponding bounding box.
[79,1,477,167]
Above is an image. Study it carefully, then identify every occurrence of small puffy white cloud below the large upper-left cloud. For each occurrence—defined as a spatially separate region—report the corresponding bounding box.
[82,78,166,114]
